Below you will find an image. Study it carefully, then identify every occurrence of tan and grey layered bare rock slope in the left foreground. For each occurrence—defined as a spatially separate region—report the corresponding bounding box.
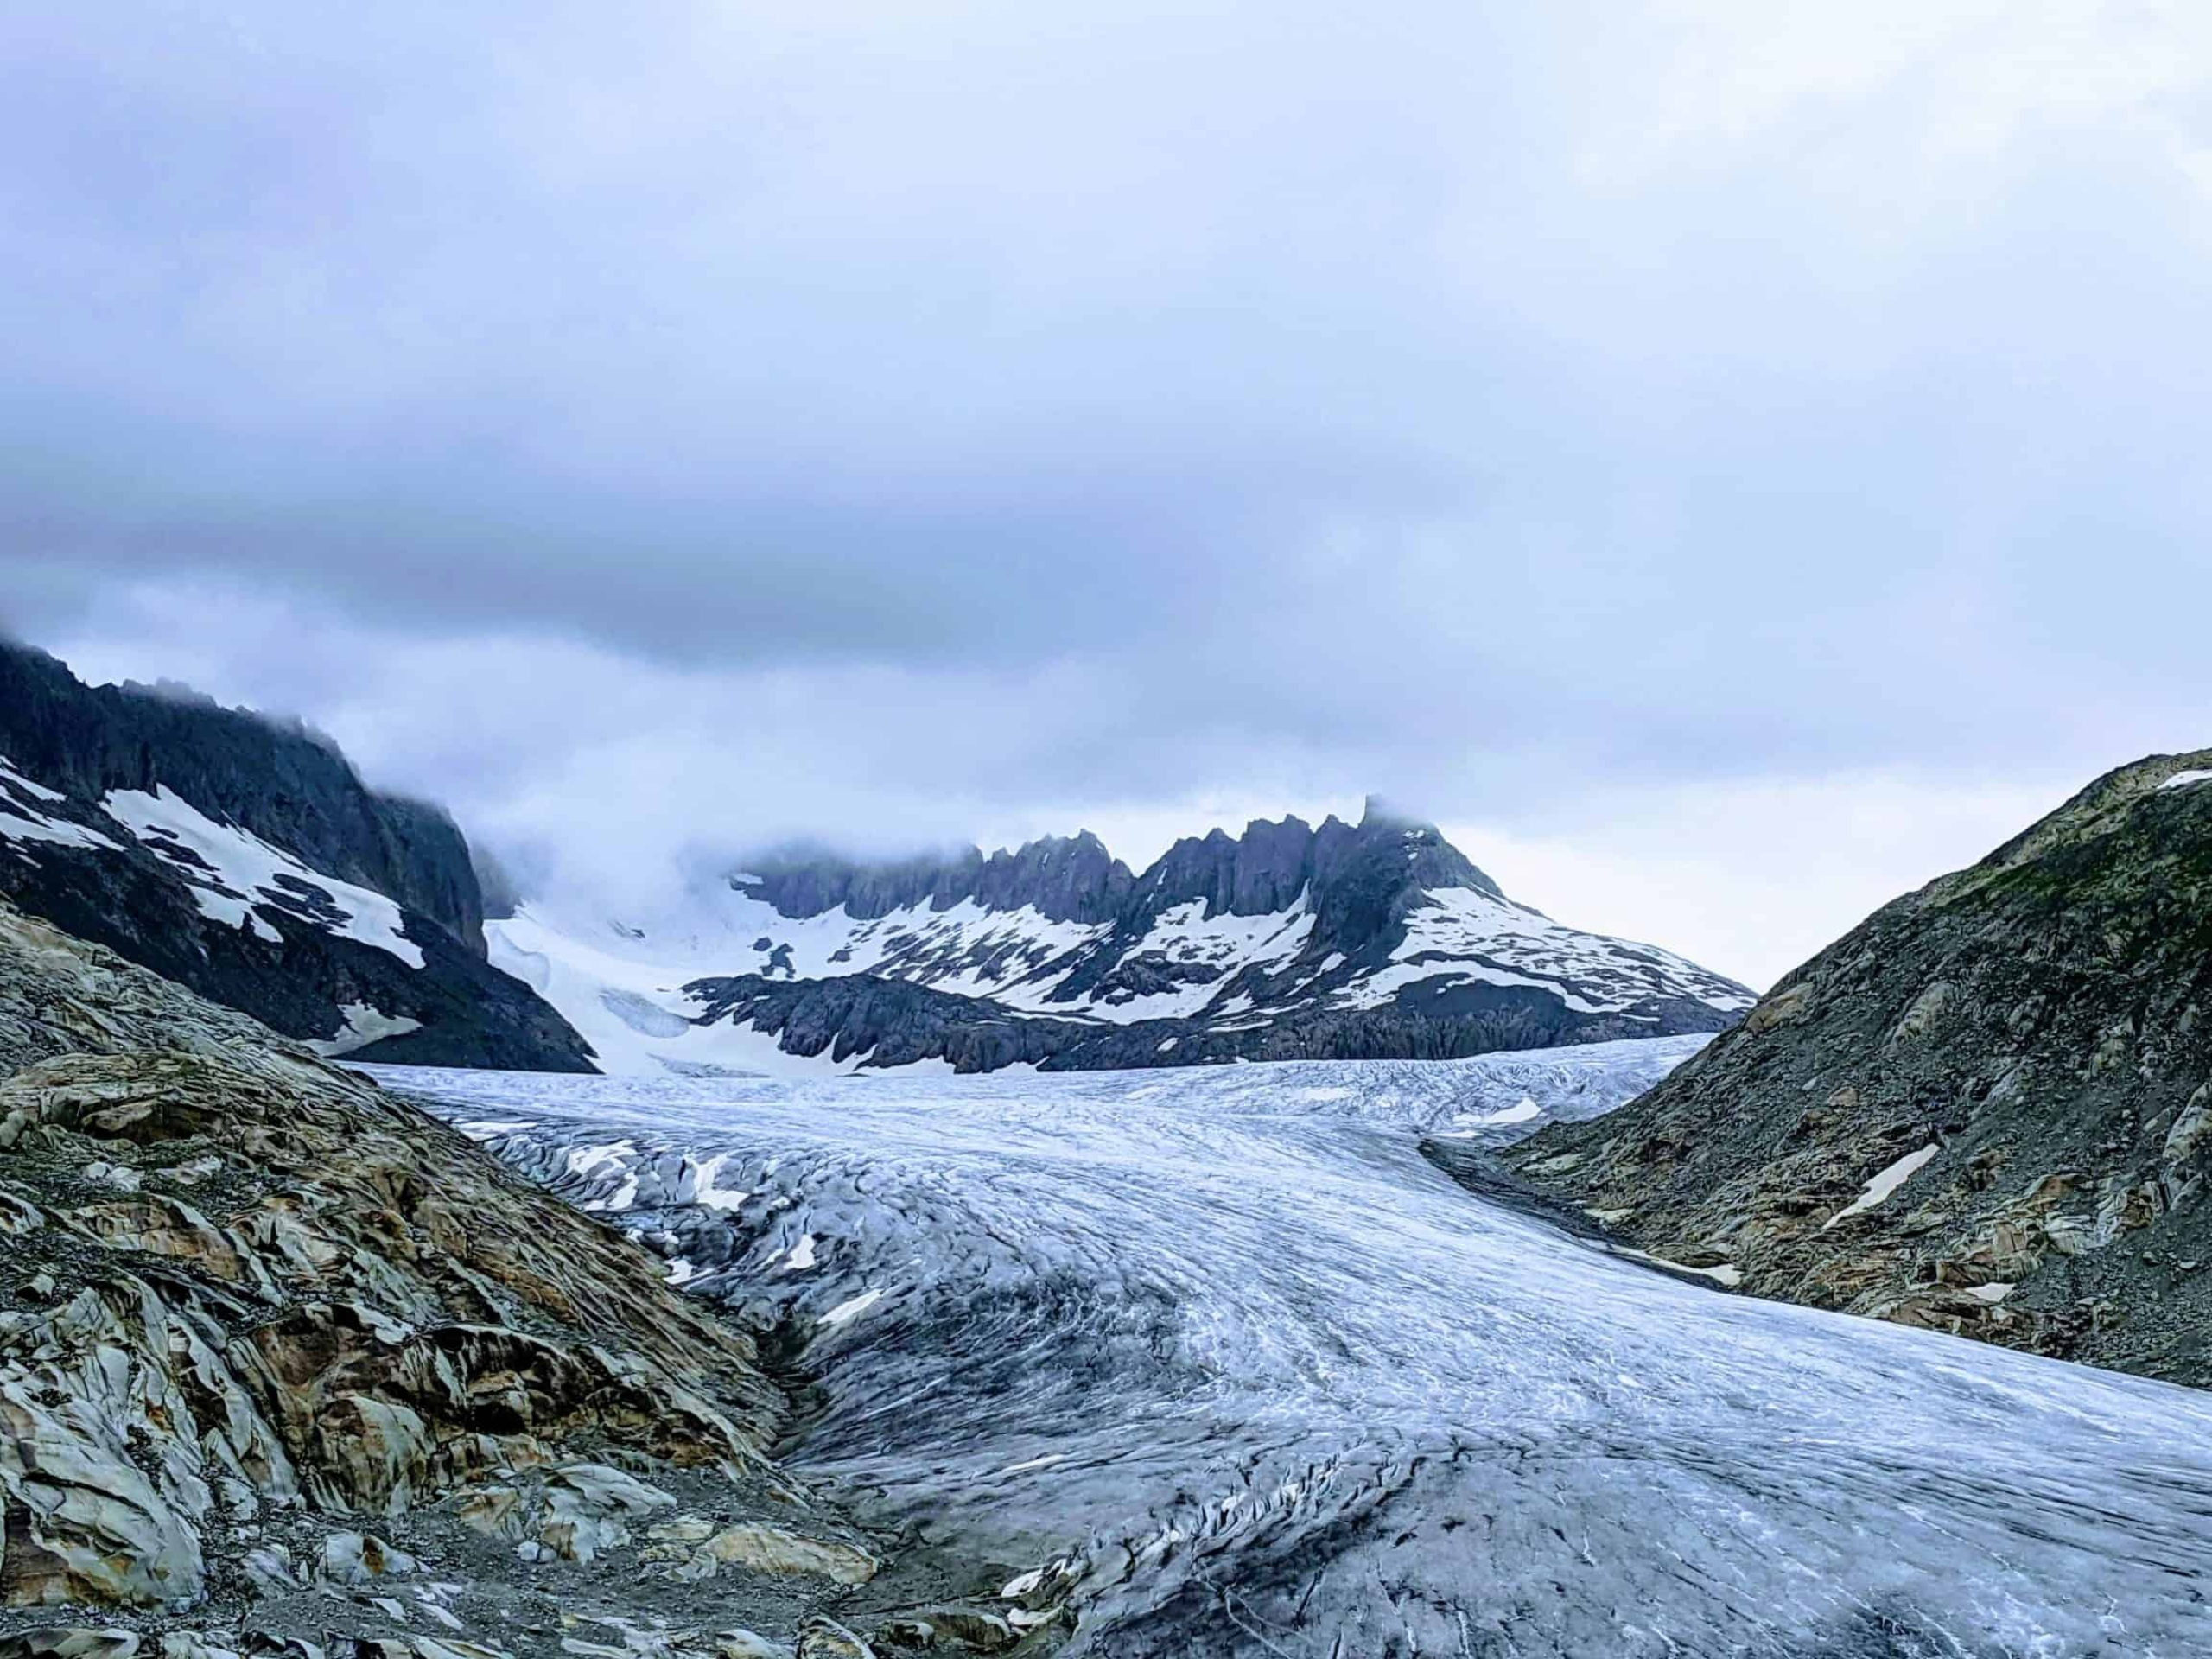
[0,905,1035,1659]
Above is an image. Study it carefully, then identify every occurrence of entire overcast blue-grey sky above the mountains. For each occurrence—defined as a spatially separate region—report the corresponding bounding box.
[0,0,2212,982]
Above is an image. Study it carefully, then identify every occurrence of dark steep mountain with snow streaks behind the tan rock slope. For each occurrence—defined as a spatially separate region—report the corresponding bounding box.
[0,644,588,1071]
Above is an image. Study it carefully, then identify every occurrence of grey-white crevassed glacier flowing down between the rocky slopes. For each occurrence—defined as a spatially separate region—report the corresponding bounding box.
[378,1038,2212,1659]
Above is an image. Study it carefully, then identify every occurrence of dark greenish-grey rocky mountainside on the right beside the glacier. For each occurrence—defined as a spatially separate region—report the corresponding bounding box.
[1509,750,2212,1385]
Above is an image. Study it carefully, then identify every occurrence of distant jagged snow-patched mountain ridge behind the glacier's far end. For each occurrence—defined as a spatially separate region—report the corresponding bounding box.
[486,801,1754,1073]
